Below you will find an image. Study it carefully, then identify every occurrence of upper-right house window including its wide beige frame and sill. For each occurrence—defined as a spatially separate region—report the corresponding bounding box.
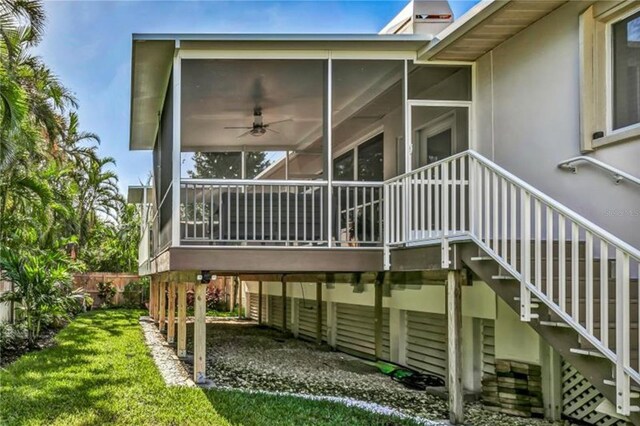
[580,2,640,151]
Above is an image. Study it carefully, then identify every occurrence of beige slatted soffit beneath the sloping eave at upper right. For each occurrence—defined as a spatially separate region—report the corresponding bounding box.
[418,0,568,62]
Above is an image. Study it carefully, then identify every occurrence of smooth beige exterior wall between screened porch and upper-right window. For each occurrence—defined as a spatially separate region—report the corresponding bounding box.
[475,2,640,247]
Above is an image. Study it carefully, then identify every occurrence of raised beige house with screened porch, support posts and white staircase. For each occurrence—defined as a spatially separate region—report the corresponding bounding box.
[130,0,640,424]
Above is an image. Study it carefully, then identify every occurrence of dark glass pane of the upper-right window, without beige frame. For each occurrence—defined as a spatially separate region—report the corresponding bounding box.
[611,11,640,130]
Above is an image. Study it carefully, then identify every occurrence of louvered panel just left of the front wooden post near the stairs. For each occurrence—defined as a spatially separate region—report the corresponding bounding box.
[406,311,447,377]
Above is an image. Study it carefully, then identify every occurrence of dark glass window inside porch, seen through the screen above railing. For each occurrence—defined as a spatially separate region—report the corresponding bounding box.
[333,133,384,181]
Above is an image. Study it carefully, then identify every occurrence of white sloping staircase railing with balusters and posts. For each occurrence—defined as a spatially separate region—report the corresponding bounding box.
[469,151,640,415]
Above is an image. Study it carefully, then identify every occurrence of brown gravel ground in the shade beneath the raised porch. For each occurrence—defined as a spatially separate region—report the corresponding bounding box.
[178,319,564,426]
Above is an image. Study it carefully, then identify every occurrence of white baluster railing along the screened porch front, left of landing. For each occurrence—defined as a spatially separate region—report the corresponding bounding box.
[180,179,383,247]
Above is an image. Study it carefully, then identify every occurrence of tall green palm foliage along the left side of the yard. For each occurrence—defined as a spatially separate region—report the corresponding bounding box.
[0,0,140,272]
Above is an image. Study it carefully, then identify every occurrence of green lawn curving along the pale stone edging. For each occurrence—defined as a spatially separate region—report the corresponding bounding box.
[0,309,424,426]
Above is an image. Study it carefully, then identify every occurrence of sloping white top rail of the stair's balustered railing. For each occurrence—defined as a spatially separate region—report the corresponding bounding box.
[465,150,640,260]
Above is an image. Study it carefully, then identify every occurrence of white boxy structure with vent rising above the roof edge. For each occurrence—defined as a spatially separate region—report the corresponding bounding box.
[380,0,453,36]
